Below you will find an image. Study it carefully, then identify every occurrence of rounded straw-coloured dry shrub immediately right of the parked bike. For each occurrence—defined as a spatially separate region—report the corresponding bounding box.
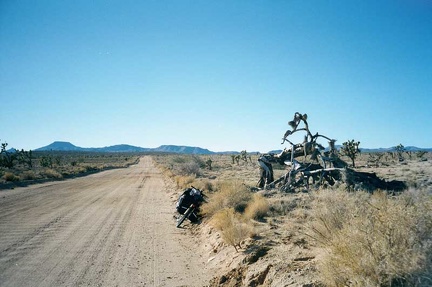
[202,181,252,217]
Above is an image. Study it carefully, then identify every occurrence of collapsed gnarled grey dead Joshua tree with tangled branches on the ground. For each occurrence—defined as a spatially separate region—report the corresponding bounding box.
[257,112,406,194]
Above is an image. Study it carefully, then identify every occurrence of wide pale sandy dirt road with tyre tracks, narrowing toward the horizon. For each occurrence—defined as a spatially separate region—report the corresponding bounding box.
[0,157,208,287]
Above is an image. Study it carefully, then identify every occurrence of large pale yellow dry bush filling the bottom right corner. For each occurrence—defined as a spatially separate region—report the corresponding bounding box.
[310,190,432,286]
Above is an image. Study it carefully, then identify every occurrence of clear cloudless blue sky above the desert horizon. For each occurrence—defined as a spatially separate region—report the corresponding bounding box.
[0,0,432,152]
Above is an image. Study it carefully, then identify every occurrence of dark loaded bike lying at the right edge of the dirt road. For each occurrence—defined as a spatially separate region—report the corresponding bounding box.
[176,186,205,227]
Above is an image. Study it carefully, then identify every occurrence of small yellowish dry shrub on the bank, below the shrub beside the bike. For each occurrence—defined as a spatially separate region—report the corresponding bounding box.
[210,208,253,251]
